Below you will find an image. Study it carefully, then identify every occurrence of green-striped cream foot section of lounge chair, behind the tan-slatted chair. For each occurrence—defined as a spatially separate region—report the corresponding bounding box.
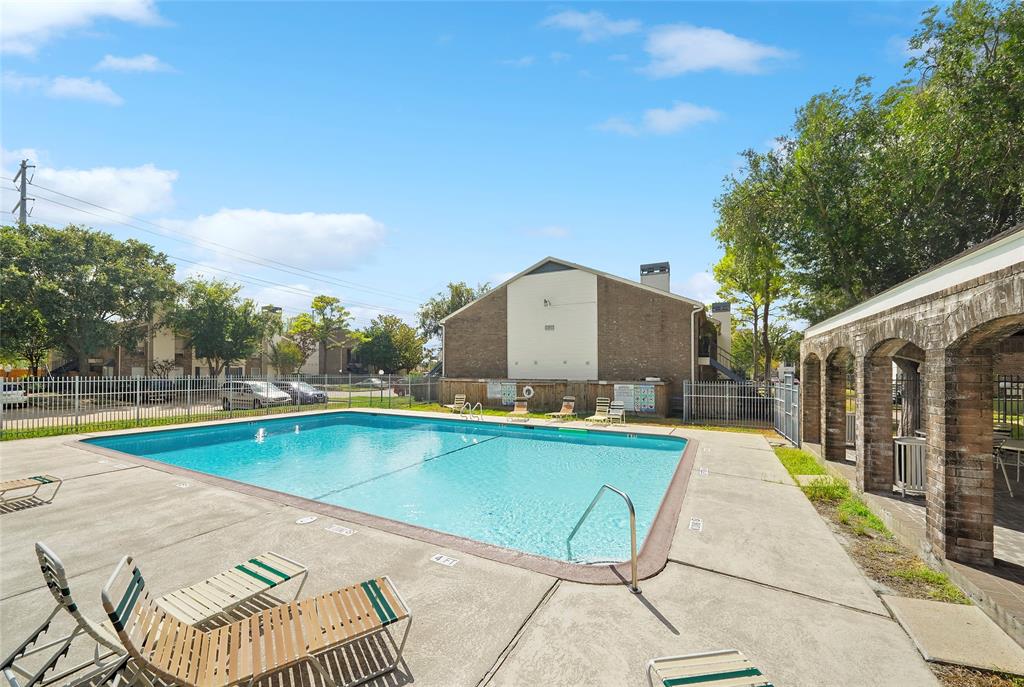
[157,551,308,625]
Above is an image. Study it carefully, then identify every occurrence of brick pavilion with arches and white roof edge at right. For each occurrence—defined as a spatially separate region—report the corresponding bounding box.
[800,225,1024,566]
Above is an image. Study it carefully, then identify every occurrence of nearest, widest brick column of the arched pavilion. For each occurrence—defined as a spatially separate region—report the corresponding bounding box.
[923,349,995,565]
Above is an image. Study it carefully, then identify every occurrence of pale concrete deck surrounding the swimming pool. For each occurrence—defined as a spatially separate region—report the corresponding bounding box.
[0,411,938,686]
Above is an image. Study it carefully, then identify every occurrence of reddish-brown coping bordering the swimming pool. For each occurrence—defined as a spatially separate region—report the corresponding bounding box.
[65,409,698,585]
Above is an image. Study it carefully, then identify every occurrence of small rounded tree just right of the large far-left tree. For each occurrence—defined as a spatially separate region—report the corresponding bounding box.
[166,278,270,377]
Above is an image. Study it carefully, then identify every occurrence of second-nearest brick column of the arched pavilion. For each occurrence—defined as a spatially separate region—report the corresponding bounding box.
[856,355,893,491]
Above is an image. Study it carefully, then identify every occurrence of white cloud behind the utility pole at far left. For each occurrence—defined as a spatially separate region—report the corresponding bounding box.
[3,148,178,225]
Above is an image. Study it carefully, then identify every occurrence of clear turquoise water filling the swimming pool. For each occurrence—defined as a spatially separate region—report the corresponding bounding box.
[88,413,685,561]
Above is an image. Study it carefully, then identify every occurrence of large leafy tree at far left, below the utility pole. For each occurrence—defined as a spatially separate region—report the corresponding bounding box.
[0,224,175,374]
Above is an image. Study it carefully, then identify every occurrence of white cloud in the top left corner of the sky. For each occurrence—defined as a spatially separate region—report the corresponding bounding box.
[0,0,161,55]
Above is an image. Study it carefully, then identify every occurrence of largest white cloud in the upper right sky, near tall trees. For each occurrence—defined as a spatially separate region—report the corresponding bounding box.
[643,24,790,78]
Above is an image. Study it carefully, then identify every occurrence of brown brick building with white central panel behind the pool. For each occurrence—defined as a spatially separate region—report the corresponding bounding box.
[442,257,717,409]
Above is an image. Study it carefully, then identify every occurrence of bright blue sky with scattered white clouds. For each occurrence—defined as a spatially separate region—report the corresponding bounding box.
[0,0,928,326]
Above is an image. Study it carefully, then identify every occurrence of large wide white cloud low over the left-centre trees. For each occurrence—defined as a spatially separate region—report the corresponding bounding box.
[161,208,386,271]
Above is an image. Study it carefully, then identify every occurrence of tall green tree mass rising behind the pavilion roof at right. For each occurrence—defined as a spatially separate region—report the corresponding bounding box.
[726,0,1024,323]
